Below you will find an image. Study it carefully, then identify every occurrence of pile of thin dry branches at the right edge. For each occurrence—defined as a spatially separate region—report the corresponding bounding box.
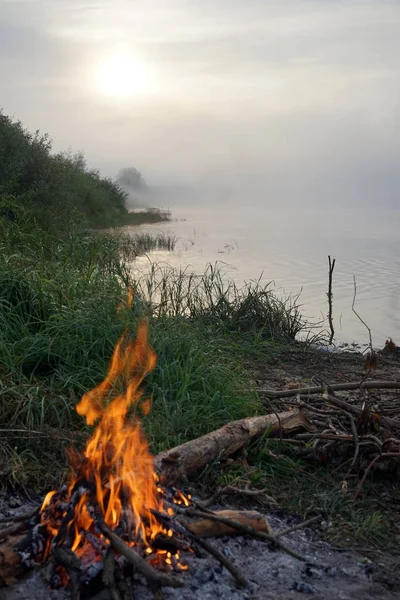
[258,380,400,498]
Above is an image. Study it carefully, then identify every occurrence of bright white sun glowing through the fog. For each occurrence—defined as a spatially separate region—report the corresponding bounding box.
[96,51,148,98]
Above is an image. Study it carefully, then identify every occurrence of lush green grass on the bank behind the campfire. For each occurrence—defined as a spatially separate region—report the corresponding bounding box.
[0,220,288,485]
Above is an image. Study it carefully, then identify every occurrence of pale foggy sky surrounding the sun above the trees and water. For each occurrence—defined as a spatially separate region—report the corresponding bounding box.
[0,0,400,206]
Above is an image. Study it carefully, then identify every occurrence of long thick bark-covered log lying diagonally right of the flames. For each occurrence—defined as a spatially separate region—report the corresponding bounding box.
[154,411,312,486]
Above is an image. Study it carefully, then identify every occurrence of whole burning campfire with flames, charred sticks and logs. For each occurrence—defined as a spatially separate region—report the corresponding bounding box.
[0,297,319,599]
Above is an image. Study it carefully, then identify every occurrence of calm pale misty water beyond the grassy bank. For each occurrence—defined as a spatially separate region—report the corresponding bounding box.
[130,207,400,347]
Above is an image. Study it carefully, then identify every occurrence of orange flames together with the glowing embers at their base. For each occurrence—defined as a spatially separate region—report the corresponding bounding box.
[36,295,188,584]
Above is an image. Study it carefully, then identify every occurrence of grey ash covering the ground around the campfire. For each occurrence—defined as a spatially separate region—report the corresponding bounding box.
[0,494,400,600]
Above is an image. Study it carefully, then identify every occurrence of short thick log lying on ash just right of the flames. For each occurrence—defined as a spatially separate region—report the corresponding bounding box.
[182,510,270,538]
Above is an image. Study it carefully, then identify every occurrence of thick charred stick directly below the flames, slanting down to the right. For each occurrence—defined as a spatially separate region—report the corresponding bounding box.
[96,516,183,588]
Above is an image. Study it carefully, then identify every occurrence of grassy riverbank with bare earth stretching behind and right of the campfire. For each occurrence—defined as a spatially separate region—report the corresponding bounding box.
[0,220,400,550]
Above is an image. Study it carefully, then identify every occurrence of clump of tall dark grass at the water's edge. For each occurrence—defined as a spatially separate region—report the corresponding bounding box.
[134,263,308,341]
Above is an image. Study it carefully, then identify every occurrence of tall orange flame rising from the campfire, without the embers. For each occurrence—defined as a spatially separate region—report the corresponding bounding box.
[73,322,162,539]
